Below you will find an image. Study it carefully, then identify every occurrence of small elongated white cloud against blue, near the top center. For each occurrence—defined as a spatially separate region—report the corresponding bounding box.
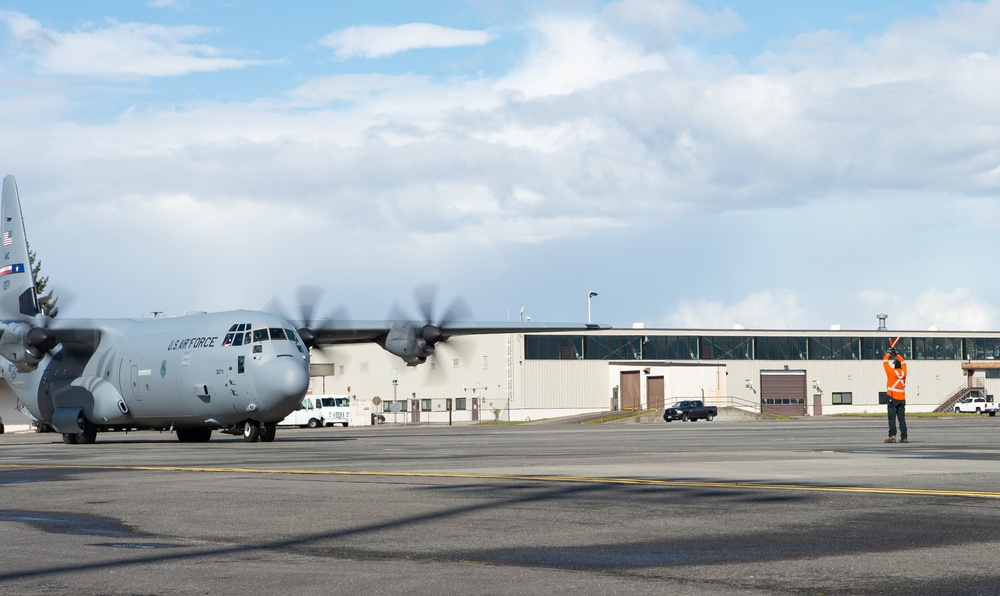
[320,23,495,59]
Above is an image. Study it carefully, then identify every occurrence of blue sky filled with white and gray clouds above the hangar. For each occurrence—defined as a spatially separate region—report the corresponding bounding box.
[0,0,1000,330]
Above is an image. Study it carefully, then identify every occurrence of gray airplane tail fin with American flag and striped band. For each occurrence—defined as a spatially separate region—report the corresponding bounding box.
[0,176,39,320]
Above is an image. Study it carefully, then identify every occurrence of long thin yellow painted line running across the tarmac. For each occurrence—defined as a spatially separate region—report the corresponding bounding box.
[0,464,1000,499]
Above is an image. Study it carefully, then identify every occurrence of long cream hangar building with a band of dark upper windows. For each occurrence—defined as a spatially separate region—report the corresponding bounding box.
[312,328,1000,422]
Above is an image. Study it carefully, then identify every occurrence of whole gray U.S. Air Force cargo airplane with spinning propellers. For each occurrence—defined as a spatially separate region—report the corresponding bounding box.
[0,176,600,444]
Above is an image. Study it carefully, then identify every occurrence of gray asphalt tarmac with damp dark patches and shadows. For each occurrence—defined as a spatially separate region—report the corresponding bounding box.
[0,415,1000,596]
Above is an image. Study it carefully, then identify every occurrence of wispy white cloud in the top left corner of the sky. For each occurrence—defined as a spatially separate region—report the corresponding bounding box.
[0,12,264,79]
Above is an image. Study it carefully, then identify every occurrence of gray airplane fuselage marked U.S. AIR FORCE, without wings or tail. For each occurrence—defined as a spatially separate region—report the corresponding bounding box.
[4,311,309,429]
